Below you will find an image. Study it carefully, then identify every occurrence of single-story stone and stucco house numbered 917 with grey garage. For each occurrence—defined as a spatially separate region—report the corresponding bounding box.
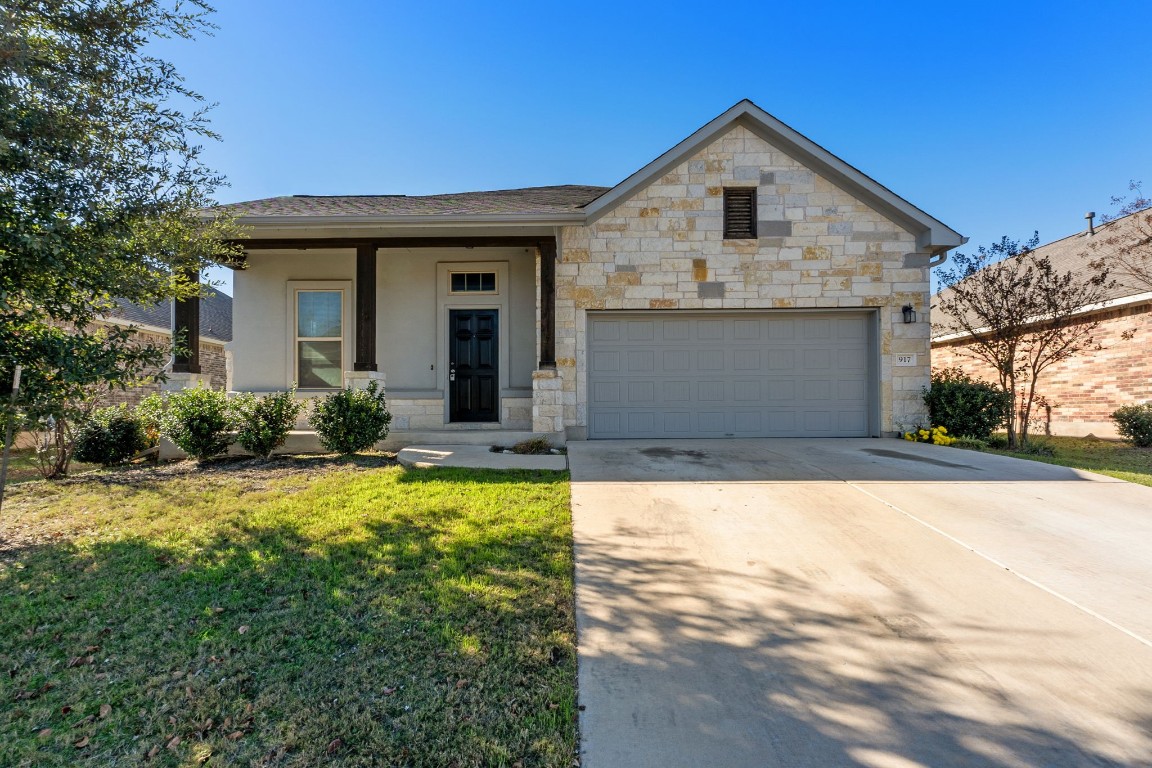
[176,100,965,441]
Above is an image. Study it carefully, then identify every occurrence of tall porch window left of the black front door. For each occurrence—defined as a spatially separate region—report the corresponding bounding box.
[296,290,344,389]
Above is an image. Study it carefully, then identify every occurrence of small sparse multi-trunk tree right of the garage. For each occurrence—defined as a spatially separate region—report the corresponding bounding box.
[933,234,1114,448]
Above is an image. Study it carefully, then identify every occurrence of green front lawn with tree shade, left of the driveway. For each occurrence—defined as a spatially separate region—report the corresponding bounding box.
[0,458,576,768]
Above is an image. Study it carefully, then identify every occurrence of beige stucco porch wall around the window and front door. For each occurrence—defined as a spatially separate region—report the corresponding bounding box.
[237,248,536,407]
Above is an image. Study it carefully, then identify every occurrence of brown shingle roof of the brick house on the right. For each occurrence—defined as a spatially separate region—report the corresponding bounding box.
[932,211,1152,341]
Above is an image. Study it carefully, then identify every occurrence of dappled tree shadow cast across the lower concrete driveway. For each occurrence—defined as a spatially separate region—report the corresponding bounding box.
[577,530,1152,768]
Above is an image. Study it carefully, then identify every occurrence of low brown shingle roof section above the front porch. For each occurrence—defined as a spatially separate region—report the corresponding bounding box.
[219,184,608,216]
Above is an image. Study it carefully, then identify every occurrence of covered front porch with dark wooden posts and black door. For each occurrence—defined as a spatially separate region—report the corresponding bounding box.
[169,234,563,451]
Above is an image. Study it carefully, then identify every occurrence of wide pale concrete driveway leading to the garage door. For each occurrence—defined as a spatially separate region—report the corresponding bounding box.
[568,440,1152,768]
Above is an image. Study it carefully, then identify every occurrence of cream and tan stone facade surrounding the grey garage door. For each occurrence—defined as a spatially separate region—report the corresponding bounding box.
[533,126,930,436]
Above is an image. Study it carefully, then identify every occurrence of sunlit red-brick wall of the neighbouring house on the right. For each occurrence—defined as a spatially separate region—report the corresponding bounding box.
[932,303,1152,438]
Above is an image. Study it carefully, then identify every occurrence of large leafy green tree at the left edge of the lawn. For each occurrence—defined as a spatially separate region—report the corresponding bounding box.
[0,0,238,476]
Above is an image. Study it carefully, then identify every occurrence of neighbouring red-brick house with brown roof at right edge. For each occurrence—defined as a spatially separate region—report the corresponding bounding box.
[932,212,1152,438]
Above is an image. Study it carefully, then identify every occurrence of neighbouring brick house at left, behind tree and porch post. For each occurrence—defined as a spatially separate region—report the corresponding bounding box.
[98,290,232,405]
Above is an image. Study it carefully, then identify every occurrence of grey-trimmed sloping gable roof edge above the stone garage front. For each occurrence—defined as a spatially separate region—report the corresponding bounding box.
[585,99,968,253]
